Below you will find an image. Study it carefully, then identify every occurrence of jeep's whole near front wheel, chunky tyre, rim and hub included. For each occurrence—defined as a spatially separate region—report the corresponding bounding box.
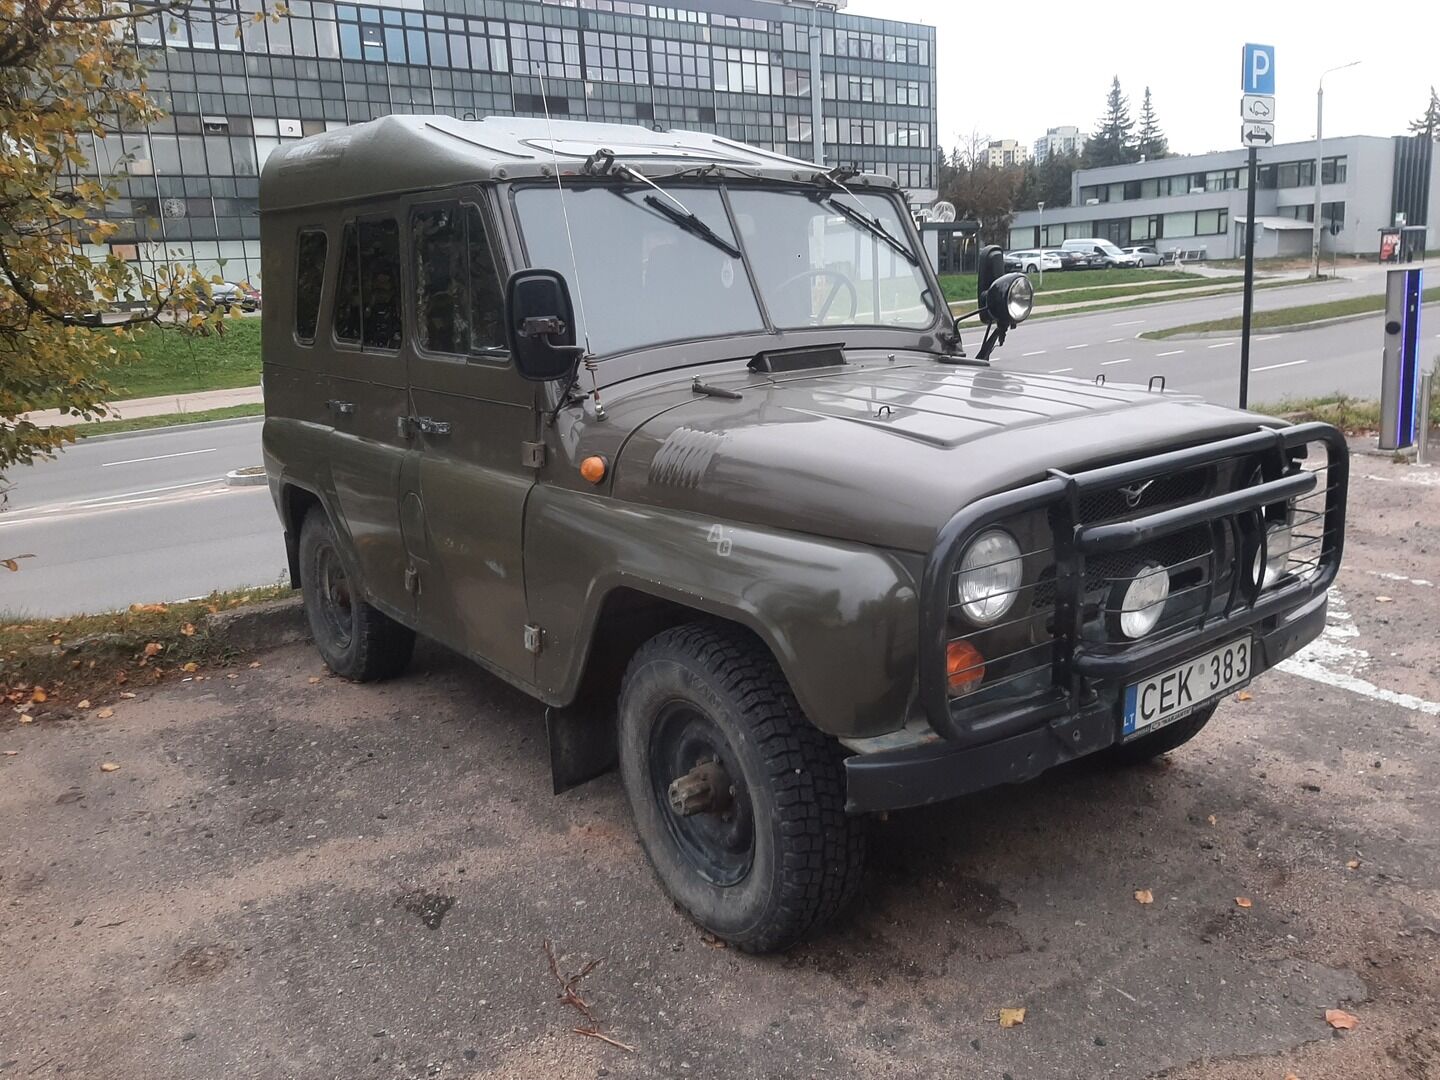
[619,624,864,952]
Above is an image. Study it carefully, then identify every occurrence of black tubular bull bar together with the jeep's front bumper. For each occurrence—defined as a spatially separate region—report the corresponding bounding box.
[847,423,1348,811]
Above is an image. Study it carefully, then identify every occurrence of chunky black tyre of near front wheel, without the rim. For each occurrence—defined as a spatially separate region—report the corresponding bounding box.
[619,624,865,953]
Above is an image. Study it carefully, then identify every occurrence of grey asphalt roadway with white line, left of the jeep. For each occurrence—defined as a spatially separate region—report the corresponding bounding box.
[0,420,285,615]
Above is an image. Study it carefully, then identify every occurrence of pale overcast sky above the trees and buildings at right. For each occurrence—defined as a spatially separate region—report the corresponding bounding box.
[845,0,1440,154]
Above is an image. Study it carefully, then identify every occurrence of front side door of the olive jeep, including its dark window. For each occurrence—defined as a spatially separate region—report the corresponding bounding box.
[402,199,539,683]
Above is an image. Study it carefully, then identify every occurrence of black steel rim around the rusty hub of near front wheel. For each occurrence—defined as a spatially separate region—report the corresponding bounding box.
[649,701,755,886]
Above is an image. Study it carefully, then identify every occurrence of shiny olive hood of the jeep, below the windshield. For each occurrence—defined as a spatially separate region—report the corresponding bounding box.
[606,353,1273,552]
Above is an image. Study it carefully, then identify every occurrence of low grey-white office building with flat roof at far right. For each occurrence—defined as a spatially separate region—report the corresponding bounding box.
[1009,135,1440,259]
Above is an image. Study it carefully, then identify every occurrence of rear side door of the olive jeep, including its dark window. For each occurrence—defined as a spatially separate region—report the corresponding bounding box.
[324,206,415,624]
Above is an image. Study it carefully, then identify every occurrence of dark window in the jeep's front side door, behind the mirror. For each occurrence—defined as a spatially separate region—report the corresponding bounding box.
[410,203,504,356]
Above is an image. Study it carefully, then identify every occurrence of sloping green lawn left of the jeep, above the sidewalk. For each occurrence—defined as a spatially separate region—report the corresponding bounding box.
[104,318,261,402]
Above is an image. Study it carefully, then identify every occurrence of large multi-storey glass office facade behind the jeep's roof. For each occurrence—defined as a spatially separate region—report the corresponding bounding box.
[78,0,936,281]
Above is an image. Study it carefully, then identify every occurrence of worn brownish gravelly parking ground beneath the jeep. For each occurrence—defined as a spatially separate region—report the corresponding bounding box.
[0,443,1440,1080]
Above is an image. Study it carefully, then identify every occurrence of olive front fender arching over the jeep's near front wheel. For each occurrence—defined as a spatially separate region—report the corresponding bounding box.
[526,485,919,737]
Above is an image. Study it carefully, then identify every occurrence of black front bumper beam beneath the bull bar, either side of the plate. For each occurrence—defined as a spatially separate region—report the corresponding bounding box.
[845,595,1326,814]
